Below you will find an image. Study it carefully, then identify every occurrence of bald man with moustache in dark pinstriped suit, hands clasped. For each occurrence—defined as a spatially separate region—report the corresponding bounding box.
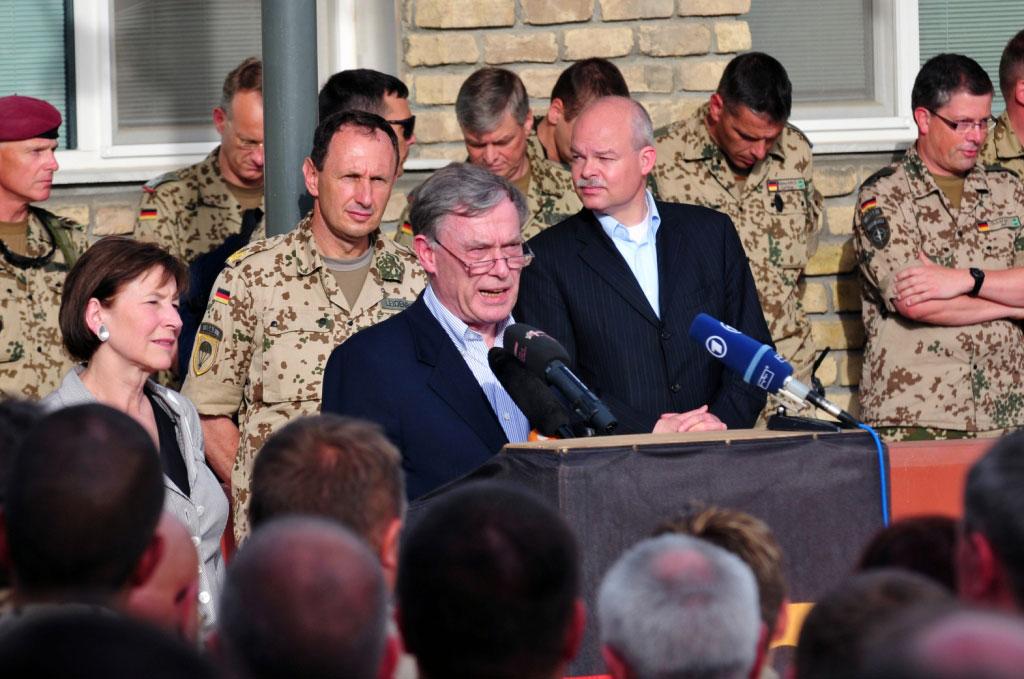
[515,97,771,433]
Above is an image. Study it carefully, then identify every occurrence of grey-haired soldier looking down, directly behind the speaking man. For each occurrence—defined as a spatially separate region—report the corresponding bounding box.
[395,69,583,246]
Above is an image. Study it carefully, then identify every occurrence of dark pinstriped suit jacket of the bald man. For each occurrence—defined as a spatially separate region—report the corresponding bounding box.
[514,203,771,433]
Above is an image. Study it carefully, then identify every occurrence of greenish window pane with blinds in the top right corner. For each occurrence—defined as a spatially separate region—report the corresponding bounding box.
[918,0,1024,115]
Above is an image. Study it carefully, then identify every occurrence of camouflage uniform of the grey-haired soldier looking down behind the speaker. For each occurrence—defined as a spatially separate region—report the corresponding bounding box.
[395,134,583,247]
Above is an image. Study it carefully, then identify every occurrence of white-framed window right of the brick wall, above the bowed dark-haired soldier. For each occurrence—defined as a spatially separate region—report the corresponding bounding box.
[746,0,919,153]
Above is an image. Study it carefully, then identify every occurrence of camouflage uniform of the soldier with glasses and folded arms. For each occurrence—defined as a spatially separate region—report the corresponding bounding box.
[854,147,1024,438]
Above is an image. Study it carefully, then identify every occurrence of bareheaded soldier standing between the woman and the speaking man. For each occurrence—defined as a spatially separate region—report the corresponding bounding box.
[182,112,426,539]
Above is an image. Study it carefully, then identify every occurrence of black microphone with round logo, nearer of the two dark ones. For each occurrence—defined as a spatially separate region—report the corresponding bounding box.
[504,323,618,434]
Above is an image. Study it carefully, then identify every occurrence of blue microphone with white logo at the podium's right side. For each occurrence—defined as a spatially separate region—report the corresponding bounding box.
[690,313,860,427]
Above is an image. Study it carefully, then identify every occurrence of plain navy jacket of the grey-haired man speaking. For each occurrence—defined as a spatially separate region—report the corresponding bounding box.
[322,295,508,500]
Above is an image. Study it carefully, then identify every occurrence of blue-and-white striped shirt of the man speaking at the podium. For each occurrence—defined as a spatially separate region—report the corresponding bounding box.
[423,286,529,443]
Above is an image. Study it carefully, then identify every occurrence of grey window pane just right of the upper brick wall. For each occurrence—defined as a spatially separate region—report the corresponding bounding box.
[746,0,874,102]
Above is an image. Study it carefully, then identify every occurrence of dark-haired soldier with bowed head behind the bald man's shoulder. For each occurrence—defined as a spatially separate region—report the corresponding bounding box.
[651,52,822,399]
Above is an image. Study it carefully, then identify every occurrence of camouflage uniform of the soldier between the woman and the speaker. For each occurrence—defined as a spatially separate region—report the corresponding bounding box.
[182,216,427,540]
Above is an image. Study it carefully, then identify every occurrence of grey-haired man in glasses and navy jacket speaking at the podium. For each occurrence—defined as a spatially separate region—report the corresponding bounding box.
[323,163,531,500]
